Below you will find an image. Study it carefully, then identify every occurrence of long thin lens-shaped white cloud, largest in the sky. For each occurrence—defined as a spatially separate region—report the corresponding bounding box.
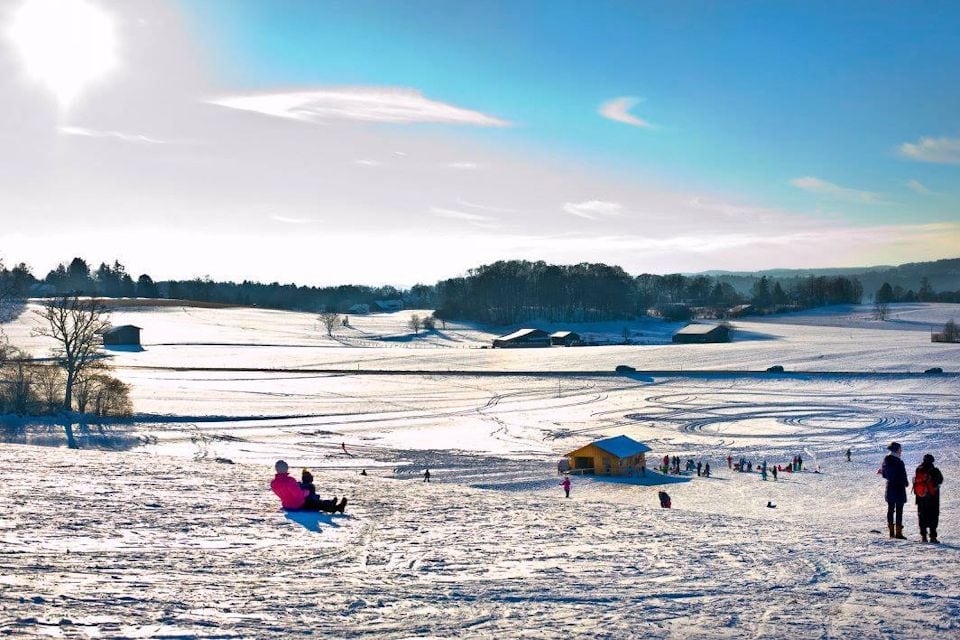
[210,87,510,127]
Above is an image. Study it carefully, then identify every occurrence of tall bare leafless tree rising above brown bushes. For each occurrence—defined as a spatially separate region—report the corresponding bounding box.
[34,296,110,412]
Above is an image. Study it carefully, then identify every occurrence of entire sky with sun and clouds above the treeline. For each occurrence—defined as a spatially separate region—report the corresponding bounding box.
[0,0,960,284]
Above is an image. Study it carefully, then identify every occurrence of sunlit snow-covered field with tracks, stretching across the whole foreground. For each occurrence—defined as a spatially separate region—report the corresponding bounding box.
[0,304,960,638]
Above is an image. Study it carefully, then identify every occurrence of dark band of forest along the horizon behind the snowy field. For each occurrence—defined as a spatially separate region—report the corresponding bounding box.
[0,258,960,325]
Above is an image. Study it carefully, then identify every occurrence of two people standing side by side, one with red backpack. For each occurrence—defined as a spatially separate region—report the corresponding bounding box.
[877,442,943,544]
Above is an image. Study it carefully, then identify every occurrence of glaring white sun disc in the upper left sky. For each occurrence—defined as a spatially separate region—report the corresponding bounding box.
[9,0,117,106]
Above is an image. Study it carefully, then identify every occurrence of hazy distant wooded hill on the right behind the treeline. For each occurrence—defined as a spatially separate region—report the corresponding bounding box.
[695,258,960,298]
